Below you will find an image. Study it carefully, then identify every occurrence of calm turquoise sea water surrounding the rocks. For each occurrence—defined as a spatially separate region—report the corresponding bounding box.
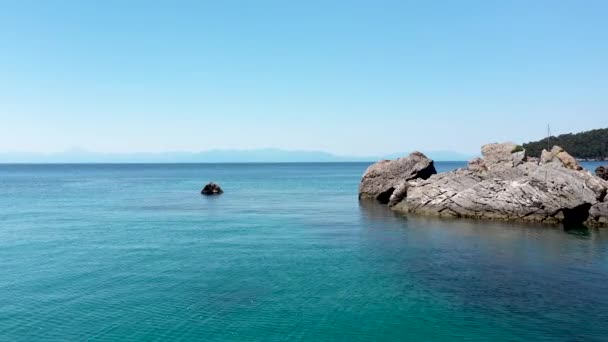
[0,163,608,341]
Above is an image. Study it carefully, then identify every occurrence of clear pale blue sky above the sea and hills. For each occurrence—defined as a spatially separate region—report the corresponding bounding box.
[0,0,608,155]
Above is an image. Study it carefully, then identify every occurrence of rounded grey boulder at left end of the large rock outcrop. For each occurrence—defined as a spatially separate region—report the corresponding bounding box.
[359,152,437,204]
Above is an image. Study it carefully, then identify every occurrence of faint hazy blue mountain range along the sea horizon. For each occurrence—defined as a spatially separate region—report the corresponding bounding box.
[0,148,474,163]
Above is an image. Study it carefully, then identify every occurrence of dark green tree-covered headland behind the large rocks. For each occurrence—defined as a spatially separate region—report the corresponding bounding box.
[523,128,608,161]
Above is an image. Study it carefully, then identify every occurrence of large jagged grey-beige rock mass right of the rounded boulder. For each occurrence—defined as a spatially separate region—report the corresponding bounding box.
[366,143,608,225]
